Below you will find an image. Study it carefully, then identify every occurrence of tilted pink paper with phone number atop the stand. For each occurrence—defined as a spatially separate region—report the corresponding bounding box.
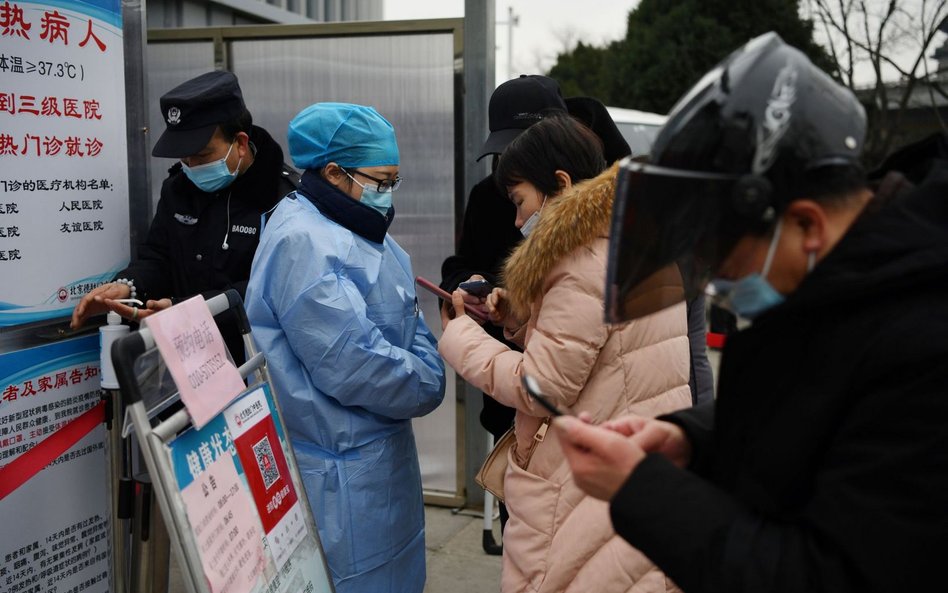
[144,295,246,429]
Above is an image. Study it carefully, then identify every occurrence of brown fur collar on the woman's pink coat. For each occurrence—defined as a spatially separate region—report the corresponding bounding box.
[504,164,619,318]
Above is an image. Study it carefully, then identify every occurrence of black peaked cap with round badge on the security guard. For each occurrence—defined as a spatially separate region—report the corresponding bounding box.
[151,70,246,158]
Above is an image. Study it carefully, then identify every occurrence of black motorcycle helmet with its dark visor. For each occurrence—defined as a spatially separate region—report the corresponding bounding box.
[606,32,866,322]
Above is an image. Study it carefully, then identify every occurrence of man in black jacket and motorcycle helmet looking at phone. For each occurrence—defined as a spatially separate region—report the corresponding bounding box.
[554,33,948,593]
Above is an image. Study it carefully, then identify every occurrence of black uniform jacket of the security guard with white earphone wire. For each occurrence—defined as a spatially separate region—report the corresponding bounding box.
[118,126,298,301]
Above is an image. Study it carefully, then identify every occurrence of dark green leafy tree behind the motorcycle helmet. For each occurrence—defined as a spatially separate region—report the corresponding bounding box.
[549,0,835,113]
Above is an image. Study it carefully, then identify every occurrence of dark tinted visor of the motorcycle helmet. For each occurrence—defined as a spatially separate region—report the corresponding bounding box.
[606,159,739,323]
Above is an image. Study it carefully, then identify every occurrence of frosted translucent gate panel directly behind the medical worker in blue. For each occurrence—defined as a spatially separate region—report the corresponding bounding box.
[230,33,457,493]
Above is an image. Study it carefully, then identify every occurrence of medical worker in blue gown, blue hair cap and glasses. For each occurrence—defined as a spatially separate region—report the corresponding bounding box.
[246,103,445,593]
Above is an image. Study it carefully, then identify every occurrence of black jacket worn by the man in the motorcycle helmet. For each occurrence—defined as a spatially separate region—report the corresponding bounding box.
[611,135,948,593]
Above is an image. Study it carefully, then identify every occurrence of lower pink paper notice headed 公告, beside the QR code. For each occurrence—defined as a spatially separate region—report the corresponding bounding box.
[181,448,264,593]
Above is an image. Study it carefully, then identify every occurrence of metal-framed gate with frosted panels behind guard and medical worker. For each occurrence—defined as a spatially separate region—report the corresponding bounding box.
[146,19,465,505]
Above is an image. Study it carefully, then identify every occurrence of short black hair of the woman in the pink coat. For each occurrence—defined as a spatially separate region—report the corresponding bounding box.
[494,114,606,196]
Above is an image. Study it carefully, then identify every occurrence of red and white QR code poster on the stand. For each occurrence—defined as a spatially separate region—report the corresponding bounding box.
[224,390,297,534]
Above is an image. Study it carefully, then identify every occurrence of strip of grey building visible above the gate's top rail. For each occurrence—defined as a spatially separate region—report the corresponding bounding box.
[145,0,382,29]
